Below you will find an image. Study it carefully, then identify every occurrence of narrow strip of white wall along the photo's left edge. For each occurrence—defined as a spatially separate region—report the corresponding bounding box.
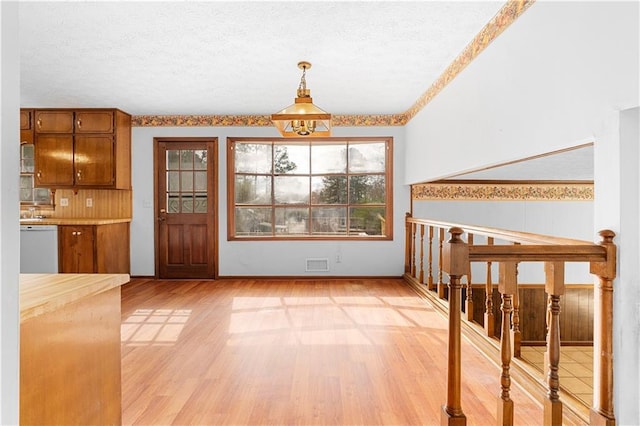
[0,2,20,425]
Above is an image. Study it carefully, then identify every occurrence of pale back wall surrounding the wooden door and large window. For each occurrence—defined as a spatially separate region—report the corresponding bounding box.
[131,127,409,276]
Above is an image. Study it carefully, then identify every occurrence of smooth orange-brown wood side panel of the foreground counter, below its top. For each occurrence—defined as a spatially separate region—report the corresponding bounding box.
[20,287,122,425]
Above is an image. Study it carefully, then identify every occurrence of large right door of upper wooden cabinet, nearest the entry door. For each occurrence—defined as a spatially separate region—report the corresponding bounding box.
[73,135,114,186]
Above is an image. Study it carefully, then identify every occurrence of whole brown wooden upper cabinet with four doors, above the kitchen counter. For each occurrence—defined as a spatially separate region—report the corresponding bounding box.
[33,109,131,189]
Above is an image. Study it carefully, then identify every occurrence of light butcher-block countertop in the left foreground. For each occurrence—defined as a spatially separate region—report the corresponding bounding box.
[20,274,130,322]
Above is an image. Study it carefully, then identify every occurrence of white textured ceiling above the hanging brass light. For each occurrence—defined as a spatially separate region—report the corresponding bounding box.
[19,1,504,115]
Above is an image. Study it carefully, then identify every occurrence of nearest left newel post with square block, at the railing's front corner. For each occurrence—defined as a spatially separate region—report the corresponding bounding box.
[441,227,469,426]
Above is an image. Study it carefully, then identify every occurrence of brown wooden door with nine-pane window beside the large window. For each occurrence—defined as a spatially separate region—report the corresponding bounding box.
[154,138,218,279]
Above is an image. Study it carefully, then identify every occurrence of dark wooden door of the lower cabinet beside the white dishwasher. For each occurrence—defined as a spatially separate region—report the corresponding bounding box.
[58,225,95,274]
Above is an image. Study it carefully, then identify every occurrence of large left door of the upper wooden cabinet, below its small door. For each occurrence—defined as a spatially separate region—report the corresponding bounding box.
[34,135,73,187]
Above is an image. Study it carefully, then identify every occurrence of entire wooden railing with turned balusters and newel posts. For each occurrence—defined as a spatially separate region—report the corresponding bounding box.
[405,214,616,426]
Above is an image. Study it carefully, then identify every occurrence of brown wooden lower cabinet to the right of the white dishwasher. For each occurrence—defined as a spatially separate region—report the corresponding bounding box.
[58,223,130,274]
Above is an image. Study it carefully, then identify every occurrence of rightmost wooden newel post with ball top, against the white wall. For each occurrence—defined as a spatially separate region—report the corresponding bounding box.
[590,229,617,426]
